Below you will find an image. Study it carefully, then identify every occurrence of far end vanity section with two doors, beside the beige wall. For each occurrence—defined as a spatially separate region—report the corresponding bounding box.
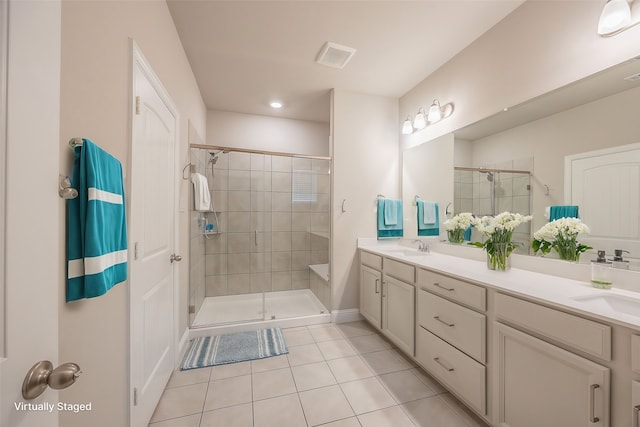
[360,251,415,356]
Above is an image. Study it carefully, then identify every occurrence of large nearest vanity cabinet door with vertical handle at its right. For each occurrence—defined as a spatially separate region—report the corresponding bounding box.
[495,323,610,427]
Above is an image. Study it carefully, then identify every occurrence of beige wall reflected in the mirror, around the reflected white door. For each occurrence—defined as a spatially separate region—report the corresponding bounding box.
[468,88,640,236]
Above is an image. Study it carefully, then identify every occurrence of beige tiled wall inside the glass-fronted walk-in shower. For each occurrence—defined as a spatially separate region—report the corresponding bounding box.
[192,149,330,296]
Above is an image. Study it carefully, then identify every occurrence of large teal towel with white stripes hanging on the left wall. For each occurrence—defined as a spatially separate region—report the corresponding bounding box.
[66,138,127,302]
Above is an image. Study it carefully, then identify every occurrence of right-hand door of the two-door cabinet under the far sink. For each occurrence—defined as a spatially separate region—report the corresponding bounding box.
[382,275,416,356]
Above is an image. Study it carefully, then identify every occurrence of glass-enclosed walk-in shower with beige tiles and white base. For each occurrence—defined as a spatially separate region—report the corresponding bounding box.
[189,144,331,328]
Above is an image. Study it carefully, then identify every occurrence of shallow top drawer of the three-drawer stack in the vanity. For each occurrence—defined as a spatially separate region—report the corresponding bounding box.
[418,268,487,311]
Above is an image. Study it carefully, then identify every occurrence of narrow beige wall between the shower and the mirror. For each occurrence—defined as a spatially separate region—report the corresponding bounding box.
[331,90,401,310]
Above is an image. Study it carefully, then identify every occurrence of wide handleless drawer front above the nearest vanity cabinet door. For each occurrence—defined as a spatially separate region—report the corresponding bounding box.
[495,294,611,361]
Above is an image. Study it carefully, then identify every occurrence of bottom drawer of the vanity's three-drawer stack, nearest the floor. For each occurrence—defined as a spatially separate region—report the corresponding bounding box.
[416,327,486,415]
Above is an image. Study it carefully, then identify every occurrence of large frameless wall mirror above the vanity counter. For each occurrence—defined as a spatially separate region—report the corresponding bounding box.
[403,58,640,258]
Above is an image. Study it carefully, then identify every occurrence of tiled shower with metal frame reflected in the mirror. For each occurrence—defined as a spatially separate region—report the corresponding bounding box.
[454,167,531,252]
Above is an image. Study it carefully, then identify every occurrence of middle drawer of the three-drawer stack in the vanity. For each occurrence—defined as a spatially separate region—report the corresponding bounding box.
[418,290,487,363]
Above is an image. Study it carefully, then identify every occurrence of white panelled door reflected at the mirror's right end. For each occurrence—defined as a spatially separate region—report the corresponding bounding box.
[565,144,640,258]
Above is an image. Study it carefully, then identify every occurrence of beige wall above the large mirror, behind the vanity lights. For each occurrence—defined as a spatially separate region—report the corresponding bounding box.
[397,0,640,149]
